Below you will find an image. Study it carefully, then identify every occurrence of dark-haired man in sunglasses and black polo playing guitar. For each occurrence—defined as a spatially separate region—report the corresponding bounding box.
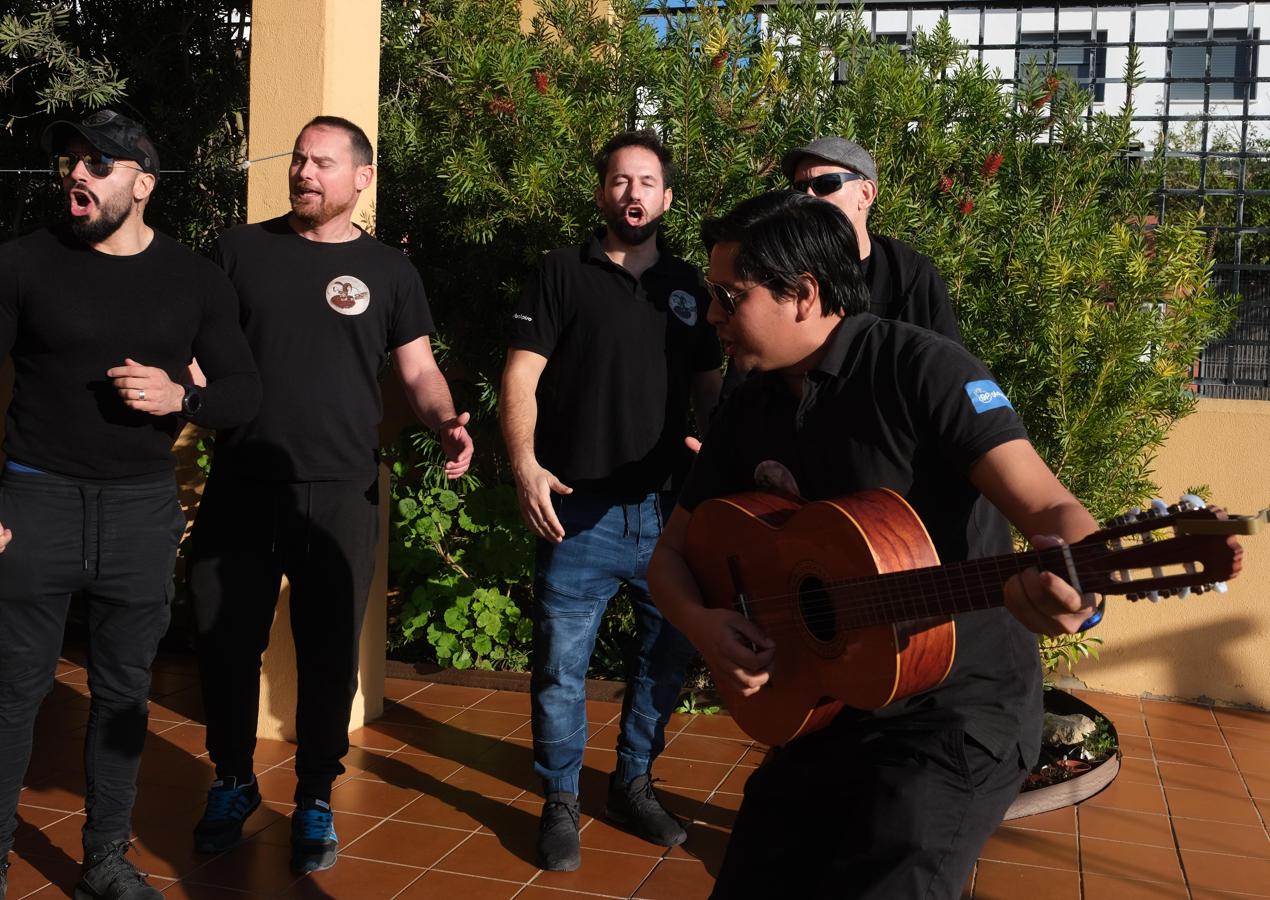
[649,192,1095,899]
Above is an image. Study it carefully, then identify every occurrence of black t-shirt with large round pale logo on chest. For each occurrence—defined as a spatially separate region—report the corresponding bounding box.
[213,216,433,481]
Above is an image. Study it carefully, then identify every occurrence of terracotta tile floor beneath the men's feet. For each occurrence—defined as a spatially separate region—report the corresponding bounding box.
[9,656,1270,900]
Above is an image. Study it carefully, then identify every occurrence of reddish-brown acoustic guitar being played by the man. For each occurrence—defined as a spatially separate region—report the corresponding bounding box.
[686,490,1266,745]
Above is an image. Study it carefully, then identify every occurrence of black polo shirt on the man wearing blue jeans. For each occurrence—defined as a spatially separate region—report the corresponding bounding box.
[511,236,720,500]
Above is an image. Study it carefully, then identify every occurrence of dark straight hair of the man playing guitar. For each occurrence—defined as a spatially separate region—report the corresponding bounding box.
[701,190,869,316]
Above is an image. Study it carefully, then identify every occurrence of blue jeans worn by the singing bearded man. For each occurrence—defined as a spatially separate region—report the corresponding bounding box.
[530,494,696,793]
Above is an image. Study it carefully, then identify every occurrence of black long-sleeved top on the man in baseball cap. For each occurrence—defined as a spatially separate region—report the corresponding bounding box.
[0,226,260,480]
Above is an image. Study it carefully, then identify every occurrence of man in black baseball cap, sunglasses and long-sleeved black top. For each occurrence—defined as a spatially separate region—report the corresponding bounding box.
[0,109,260,900]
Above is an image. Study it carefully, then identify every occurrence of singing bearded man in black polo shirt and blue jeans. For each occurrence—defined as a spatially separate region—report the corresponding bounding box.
[499,132,720,870]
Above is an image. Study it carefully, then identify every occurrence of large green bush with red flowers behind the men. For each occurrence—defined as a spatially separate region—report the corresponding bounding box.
[377,0,1232,659]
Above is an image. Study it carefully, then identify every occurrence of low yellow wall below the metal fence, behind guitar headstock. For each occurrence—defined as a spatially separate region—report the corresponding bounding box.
[1074,400,1270,708]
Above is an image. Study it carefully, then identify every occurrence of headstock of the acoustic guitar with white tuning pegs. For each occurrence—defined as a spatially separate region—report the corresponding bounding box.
[1072,494,1254,602]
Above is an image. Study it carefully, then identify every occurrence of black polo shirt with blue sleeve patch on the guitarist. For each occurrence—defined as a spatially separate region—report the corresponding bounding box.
[679,314,1040,759]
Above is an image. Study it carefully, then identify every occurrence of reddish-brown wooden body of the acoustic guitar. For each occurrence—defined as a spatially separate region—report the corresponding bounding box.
[686,490,956,745]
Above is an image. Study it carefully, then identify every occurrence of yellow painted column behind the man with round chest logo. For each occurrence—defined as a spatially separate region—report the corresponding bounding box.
[246,0,387,740]
